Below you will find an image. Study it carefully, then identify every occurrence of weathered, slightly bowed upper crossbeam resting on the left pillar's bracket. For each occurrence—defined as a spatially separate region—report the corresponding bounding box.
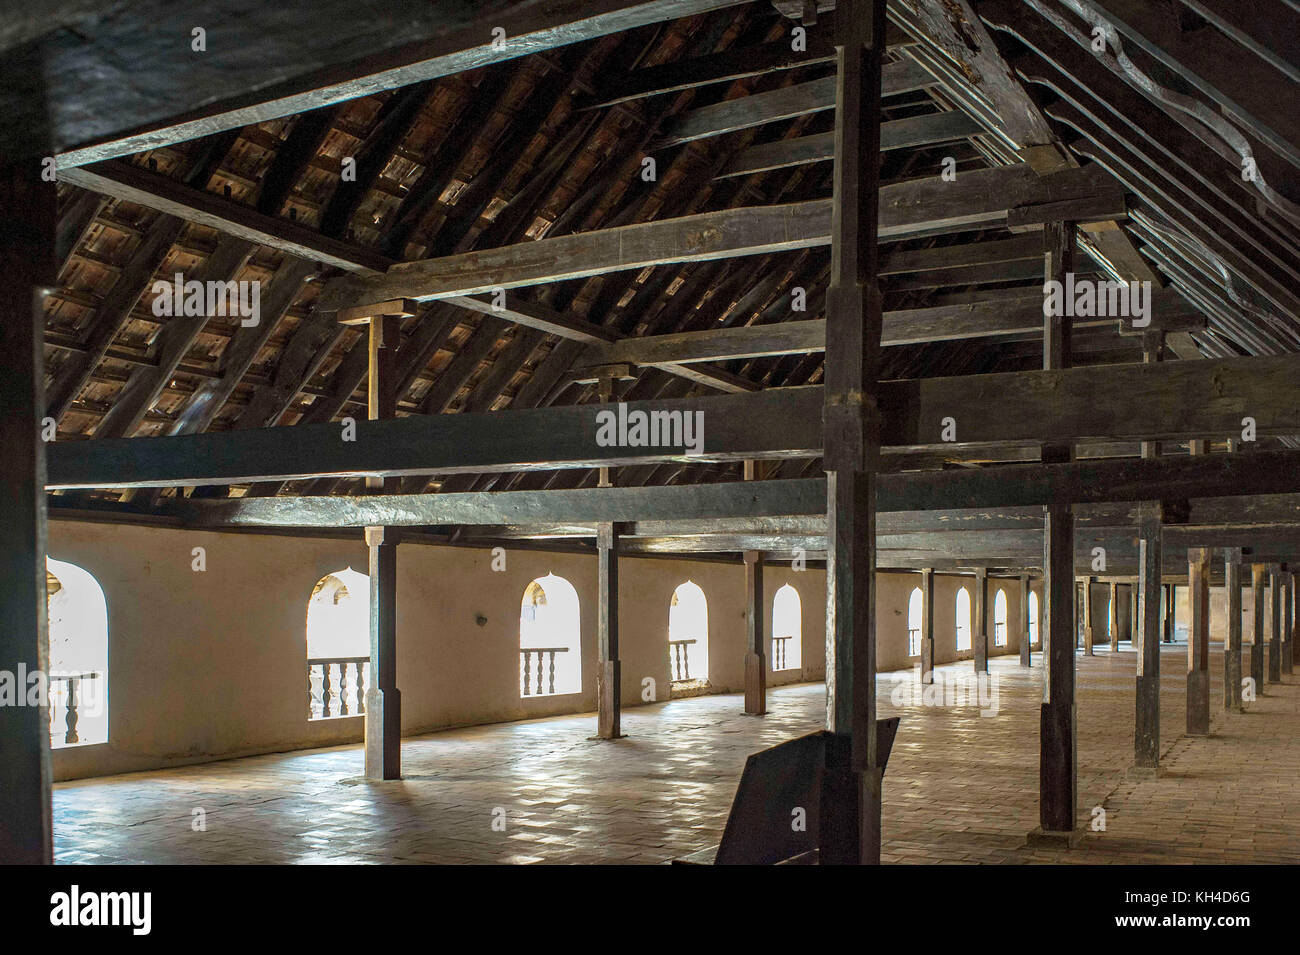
[317,165,1128,311]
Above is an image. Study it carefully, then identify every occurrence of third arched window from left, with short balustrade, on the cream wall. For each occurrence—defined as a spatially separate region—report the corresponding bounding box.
[519,574,582,696]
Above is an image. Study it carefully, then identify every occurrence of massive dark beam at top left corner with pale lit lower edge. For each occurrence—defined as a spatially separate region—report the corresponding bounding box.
[43,0,754,168]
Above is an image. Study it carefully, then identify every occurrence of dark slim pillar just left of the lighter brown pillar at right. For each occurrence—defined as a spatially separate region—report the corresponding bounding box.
[1134,502,1162,769]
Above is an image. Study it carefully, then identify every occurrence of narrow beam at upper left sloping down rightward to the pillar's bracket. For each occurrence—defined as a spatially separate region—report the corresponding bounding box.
[59,160,391,275]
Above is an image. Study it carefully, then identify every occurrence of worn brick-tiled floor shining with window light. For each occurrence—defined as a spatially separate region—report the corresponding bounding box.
[55,646,1300,863]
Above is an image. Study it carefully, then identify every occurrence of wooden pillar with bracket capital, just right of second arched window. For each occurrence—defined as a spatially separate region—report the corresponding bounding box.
[338,307,416,780]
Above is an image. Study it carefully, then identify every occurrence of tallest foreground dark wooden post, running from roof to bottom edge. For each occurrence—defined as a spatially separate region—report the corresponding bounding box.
[819,0,885,864]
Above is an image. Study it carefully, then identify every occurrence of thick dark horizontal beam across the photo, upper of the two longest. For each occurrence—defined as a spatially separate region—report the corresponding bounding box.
[48,355,1300,488]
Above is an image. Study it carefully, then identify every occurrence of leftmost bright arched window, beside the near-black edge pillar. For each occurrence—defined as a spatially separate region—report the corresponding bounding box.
[46,557,108,750]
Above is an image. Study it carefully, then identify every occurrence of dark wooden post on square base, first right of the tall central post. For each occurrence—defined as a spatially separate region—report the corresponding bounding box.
[1031,222,1078,841]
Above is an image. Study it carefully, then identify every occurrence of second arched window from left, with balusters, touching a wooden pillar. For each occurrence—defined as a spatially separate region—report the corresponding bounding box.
[307,568,371,720]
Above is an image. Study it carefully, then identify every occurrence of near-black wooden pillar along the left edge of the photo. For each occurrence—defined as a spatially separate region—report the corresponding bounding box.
[0,76,57,864]
